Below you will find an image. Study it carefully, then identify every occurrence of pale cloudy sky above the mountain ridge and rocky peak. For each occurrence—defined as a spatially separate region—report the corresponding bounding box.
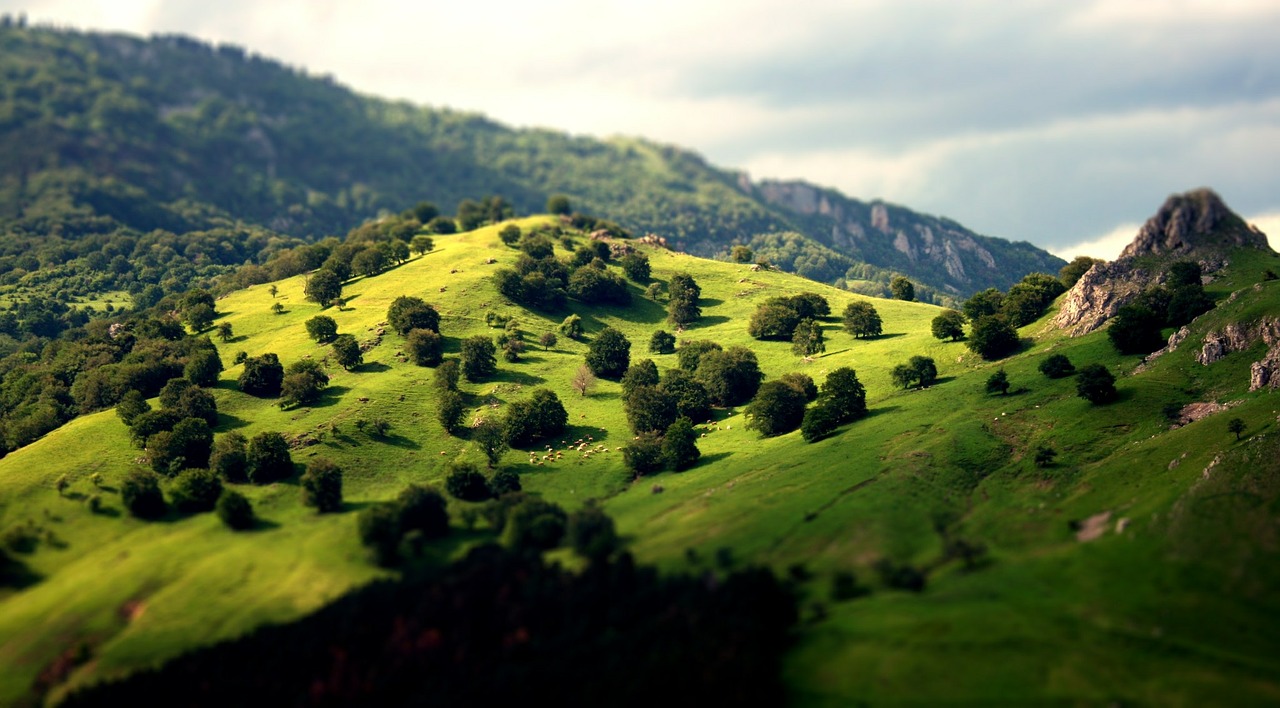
[10,0,1280,259]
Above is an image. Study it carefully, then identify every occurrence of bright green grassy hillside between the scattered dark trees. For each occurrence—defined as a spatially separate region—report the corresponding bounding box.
[0,219,1280,704]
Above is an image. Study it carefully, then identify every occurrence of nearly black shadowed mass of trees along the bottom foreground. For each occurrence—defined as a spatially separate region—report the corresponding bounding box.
[64,544,796,707]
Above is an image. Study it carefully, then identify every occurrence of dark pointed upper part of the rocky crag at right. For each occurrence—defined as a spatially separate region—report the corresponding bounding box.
[1120,189,1268,260]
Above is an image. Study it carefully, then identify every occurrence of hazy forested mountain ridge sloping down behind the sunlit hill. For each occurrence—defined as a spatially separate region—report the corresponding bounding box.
[0,23,1064,300]
